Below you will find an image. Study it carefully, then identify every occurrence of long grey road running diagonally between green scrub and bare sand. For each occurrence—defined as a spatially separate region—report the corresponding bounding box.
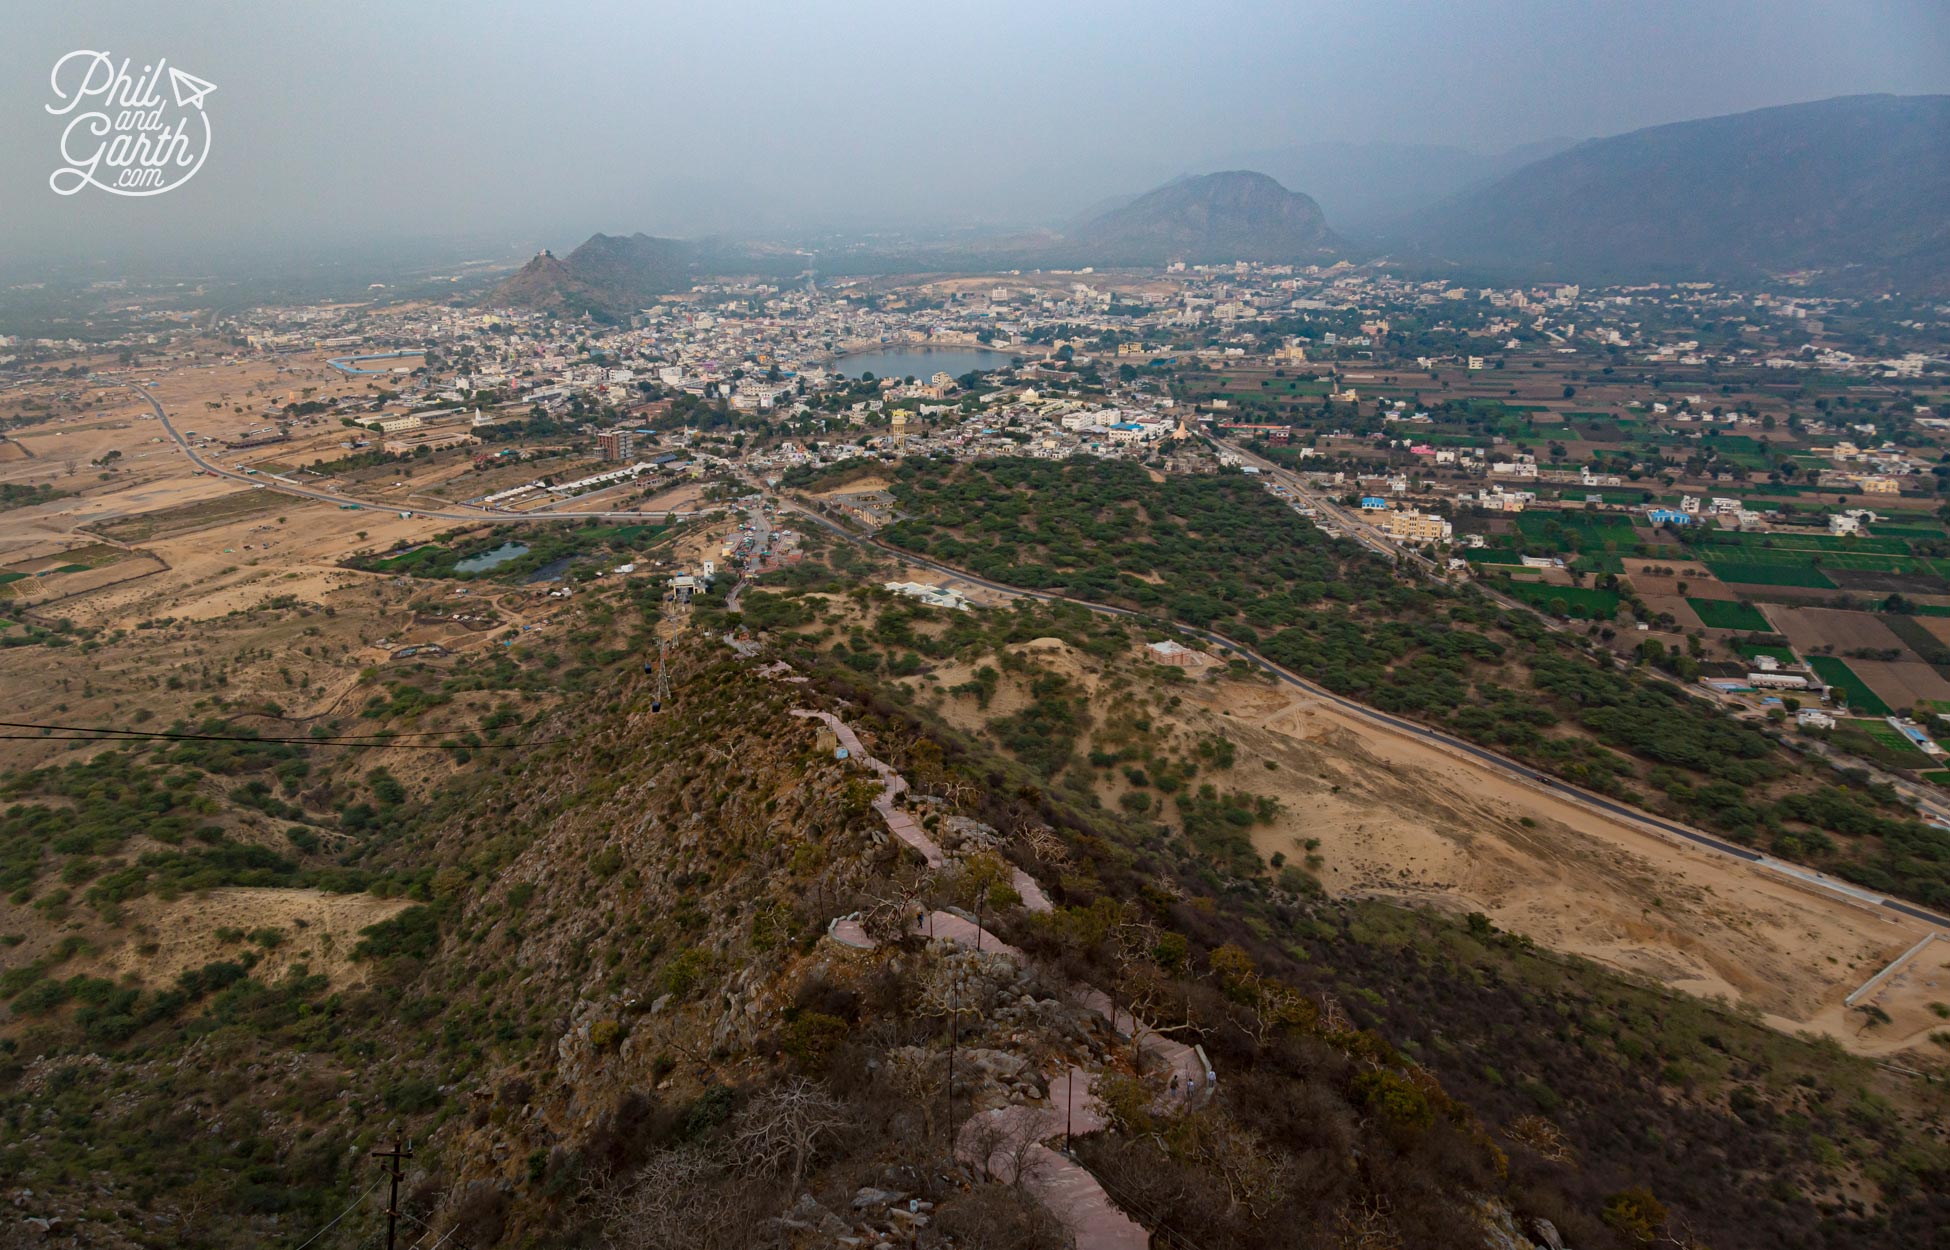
[772,487,1950,932]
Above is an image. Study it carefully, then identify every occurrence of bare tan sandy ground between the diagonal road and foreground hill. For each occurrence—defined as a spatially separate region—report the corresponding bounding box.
[930,640,1950,1055]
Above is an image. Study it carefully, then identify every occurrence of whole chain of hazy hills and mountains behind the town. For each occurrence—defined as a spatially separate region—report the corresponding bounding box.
[489,96,1950,308]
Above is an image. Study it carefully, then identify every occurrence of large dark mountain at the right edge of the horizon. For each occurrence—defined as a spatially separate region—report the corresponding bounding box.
[1396,96,1950,294]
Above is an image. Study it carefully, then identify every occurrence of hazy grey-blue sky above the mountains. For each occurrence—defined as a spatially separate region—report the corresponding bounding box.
[0,0,1950,267]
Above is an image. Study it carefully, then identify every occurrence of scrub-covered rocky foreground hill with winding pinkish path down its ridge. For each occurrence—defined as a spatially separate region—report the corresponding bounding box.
[0,540,1950,1250]
